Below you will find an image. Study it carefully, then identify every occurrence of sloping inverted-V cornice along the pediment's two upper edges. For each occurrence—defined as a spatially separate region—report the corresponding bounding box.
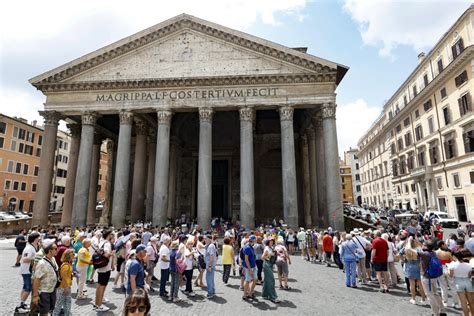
[30,15,344,90]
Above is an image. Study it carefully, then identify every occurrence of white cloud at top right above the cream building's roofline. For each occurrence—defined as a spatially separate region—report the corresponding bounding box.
[344,0,471,57]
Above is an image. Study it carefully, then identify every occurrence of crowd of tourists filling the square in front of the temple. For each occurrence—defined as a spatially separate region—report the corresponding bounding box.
[10,216,474,315]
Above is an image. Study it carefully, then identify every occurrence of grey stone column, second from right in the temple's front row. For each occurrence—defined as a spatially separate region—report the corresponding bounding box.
[279,106,298,229]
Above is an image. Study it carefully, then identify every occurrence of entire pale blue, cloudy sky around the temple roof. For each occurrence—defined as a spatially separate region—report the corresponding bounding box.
[0,0,471,156]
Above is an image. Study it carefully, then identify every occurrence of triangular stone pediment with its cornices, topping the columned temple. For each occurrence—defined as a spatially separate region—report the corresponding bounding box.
[30,14,347,90]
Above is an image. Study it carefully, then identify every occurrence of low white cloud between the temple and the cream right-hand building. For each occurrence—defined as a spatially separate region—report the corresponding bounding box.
[336,99,380,157]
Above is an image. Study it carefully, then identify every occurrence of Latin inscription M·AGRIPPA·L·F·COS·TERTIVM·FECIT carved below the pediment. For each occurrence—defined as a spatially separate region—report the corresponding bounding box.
[96,88,278,102]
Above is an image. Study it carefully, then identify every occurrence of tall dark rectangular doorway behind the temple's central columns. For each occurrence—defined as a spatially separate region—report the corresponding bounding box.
[212,160,229,219]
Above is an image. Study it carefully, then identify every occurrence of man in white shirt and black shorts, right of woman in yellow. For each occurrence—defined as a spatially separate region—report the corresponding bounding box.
[94,230,115,312]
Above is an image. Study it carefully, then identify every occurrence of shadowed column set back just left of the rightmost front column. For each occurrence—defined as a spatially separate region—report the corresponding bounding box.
[312,112,329,227]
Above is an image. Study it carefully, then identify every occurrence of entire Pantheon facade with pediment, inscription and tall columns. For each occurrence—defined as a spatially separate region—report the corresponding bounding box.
[30,14,348,229]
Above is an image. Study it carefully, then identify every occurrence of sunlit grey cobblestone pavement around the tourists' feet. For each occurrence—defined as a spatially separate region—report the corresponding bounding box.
[0,240,461,316]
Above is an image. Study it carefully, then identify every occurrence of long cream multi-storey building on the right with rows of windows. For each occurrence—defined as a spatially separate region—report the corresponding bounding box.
[358,6,474,221]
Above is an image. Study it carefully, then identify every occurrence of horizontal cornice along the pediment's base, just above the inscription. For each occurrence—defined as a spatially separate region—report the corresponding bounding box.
[36,72,336,93]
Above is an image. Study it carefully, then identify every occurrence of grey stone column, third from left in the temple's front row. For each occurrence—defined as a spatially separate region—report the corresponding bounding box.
[111,111,133,228]
